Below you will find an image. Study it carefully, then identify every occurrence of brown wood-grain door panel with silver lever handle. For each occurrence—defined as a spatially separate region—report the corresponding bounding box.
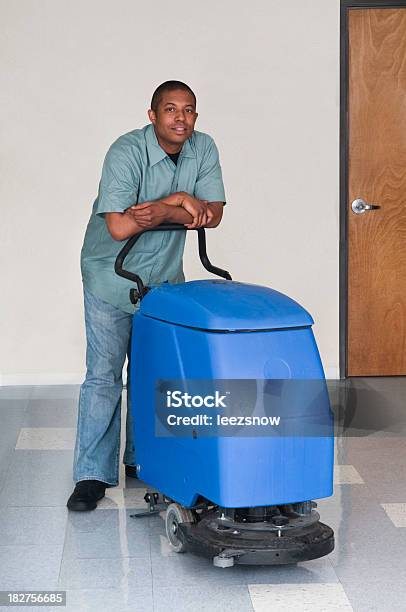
[347,8,406,376]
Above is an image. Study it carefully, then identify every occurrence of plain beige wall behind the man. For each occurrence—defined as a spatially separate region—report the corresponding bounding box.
[0,0,339,384]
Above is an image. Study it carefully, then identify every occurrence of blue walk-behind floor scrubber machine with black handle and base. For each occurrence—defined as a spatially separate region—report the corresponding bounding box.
[115,224,334,567]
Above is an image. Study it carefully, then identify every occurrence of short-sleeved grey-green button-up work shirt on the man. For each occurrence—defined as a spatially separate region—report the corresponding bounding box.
[81,124,225,313]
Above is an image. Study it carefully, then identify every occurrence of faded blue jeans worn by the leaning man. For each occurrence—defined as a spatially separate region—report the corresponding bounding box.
[73,289,135,486]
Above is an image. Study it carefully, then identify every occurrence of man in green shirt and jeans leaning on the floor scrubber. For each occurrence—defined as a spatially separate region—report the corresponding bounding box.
[67,81,225,511]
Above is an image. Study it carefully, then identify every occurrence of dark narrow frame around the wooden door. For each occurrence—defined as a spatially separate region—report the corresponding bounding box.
[339,0,406,379]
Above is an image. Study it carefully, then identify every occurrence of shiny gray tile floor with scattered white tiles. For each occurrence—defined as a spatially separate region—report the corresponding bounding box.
[0,378,406,612]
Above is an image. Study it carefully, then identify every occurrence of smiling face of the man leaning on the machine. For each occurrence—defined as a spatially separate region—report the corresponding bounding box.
[148,89,197,153]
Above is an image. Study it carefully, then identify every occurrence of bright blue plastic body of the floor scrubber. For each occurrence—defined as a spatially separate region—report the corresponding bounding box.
[130,280,334,508]
